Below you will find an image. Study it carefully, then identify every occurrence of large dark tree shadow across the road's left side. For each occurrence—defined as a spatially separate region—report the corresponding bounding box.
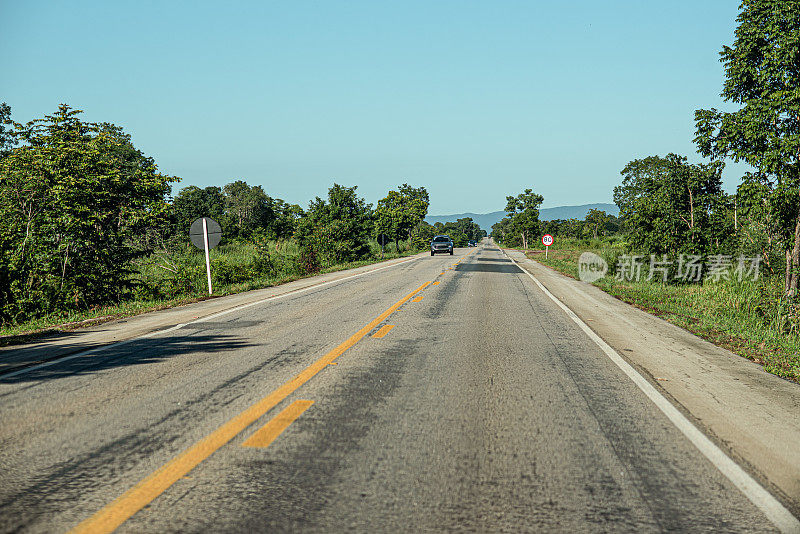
[0,333,252,384]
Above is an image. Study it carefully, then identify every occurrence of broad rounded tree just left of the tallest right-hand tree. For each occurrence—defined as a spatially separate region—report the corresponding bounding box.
[614,154,726,254]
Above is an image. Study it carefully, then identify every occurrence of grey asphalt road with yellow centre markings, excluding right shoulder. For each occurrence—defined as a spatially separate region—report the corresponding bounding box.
[0,246,788,532]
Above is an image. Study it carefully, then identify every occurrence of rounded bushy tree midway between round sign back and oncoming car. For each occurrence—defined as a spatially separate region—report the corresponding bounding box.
[295,184,373,265]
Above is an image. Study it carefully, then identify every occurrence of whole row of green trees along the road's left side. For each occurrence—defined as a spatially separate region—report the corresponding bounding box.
[0,103,485,324]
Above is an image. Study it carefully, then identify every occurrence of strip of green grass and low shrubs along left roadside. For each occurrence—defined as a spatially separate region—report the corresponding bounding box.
[0,242,418,347]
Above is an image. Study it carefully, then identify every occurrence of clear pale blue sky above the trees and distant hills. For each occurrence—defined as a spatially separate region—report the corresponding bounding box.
[0,0,744,214]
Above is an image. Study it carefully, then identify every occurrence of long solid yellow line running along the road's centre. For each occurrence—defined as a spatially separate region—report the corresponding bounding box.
[71,282,430,533]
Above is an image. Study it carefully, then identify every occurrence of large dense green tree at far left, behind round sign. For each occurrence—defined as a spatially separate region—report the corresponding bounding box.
[0,105,176,322]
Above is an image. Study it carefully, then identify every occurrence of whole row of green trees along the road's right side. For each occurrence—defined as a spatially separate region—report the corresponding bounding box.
[492,0,800,299]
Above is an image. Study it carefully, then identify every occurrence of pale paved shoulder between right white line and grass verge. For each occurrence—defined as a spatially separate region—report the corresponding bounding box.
[506,250,800,514]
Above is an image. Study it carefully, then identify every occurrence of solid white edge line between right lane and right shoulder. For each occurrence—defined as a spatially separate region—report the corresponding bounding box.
[500,249,800,534]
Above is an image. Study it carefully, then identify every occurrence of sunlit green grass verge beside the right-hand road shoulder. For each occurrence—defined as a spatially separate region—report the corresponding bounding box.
[516,238,800,382]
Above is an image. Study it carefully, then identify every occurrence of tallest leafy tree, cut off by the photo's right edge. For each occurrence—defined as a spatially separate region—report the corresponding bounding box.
[695,0,800,296]
